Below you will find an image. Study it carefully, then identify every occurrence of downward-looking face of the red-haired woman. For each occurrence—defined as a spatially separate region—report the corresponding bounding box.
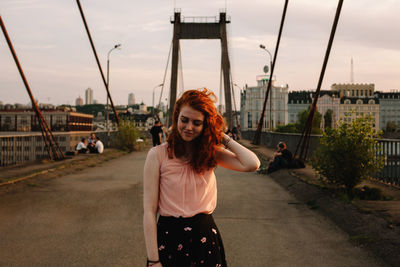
[178,106,204,142]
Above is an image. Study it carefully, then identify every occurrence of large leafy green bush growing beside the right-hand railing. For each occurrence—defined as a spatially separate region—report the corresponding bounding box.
[312,117,383,199]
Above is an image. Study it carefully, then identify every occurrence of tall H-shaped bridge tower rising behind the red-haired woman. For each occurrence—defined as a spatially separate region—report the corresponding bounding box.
[168,9,232,129]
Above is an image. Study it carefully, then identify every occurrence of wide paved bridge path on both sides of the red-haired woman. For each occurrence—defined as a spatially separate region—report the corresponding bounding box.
[0,152,379,267]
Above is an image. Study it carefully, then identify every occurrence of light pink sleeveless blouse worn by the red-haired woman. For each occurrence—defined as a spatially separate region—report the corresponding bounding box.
[152,143,217,217]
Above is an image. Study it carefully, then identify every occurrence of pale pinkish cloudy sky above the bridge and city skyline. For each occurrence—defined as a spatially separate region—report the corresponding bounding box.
[0,0,400,108]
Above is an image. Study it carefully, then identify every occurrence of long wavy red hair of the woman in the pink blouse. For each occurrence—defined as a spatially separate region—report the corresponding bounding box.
[168,88,225,173]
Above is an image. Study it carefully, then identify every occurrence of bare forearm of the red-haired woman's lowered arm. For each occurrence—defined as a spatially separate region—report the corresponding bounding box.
[143,212,159,260]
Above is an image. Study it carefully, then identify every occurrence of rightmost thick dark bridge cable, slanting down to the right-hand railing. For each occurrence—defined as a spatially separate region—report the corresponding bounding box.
[293,0,343,161]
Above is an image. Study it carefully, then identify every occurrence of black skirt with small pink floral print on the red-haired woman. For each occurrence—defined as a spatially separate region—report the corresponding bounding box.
[157,213,227,267]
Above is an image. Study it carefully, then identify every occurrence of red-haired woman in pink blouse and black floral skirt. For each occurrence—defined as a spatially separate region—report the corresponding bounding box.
[143,89,260,267]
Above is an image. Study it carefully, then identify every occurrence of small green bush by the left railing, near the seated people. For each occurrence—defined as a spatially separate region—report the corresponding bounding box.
[117,120,139,152]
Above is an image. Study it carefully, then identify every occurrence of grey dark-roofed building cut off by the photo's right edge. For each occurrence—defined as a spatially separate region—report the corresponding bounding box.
[375,91,400,130]
